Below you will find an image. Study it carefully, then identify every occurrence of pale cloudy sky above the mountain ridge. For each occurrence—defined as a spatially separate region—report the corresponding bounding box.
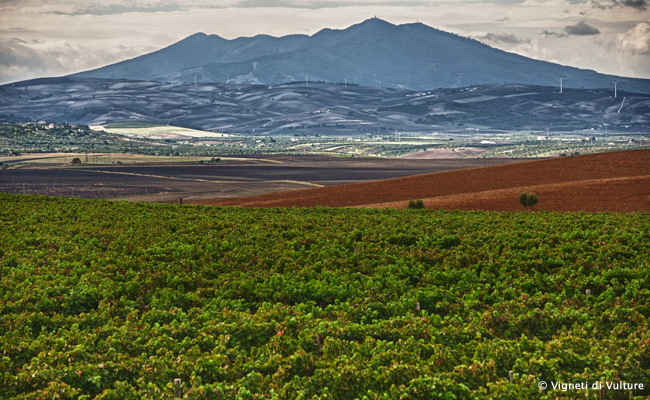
[0,0,650,84]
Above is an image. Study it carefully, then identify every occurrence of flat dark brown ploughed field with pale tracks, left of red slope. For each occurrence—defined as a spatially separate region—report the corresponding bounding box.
[0,153,517,203]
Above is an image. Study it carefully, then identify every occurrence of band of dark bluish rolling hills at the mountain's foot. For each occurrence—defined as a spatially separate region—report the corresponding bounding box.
[0,77,650,135]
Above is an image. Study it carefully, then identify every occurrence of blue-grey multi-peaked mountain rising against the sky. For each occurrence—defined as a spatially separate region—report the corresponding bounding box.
[72,18,650,93]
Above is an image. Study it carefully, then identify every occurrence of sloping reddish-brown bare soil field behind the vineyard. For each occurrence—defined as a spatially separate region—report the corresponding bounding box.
[194,149,650,212]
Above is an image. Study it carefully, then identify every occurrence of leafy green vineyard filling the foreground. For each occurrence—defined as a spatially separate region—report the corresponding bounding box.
[0,194,650,400]
